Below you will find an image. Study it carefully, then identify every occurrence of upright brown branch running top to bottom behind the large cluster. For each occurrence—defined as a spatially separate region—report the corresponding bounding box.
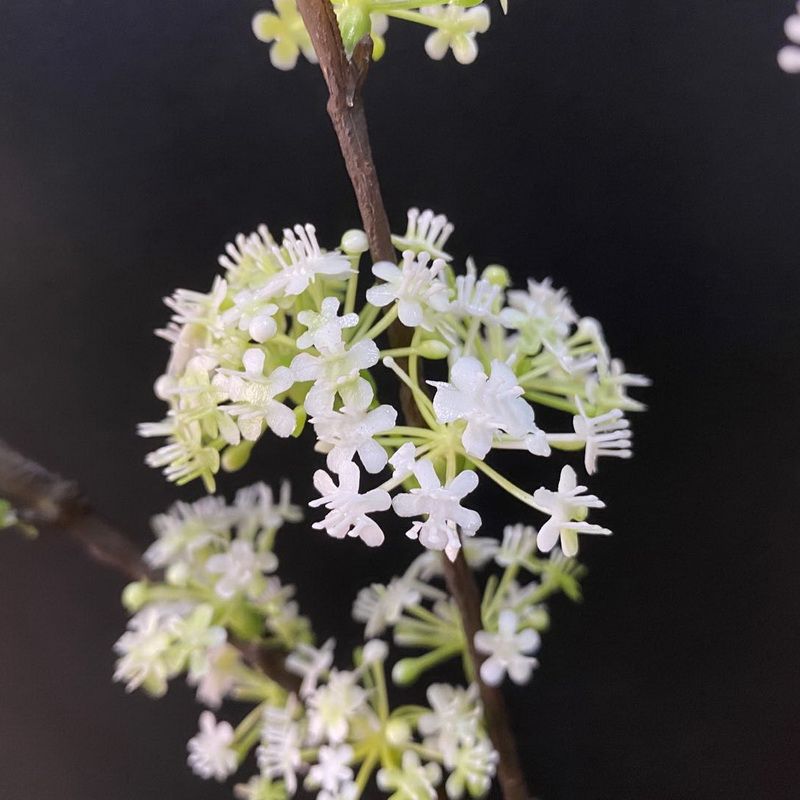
[297,0,528,800]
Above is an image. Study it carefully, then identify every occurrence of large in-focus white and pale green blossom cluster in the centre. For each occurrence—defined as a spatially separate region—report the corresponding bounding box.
[140,208,648,564]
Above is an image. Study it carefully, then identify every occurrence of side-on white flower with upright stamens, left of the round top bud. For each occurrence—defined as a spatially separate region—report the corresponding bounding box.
[264,225,352,296]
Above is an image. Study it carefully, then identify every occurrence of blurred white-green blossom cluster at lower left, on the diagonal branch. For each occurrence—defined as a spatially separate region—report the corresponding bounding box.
[114,483,311,706]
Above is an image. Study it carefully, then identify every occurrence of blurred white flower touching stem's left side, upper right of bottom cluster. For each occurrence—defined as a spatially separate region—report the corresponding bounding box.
[417,683,481,767]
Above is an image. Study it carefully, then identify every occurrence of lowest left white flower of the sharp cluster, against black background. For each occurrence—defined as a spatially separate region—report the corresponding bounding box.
[309,461,392,547]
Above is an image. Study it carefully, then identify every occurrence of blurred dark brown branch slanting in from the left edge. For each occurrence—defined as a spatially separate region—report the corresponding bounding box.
[0,439,300,692]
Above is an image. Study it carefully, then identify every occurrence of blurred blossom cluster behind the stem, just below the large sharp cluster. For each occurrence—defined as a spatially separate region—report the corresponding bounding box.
[353,524,583,686]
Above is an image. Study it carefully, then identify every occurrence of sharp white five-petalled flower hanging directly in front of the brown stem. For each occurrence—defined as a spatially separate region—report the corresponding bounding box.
[393,459,481,561]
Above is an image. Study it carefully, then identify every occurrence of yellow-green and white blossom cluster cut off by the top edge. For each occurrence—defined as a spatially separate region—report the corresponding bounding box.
[253,0,496,70]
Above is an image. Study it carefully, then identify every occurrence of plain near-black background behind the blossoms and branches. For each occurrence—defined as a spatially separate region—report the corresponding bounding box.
[0,0,800,800]
